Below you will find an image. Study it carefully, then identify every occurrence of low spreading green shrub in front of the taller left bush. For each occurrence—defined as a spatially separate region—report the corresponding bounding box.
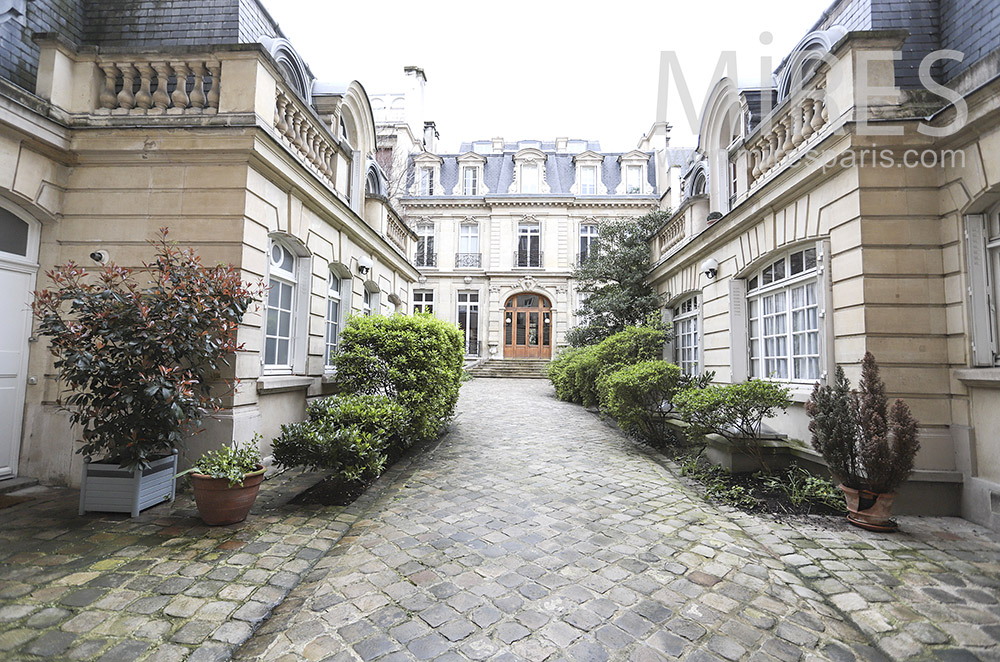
[273,395,407,481]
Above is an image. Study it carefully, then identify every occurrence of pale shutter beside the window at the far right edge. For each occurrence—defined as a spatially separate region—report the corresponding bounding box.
[965,214,996,366]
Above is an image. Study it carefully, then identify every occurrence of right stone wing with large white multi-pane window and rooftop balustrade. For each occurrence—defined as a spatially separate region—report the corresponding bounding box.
[650,0,1000,528]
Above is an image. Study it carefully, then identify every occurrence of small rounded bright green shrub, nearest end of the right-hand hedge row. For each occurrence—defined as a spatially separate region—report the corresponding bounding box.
[598,361,681,445]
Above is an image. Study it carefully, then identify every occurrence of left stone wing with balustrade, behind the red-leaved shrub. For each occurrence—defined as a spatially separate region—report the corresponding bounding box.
[0,0,418,484]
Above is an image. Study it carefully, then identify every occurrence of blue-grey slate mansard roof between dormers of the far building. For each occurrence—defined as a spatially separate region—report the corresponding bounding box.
[411,140,656,197]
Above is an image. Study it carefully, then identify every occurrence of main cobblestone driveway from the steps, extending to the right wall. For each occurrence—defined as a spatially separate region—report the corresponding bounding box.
[236,380,1000,662]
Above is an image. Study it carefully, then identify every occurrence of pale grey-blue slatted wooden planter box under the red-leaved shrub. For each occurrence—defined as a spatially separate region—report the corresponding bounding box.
[80,450,177,517]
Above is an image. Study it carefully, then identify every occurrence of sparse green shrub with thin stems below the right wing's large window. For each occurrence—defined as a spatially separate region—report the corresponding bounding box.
[673,379,792,466]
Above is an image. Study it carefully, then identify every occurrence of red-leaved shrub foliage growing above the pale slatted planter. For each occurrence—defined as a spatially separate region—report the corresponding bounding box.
[32,228,263,468]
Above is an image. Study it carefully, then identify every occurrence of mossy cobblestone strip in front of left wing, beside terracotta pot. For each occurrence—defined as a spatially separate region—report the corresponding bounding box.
[0,461,418,662]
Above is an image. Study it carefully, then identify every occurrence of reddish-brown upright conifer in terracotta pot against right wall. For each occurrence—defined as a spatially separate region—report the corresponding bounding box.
[806,352,920,531]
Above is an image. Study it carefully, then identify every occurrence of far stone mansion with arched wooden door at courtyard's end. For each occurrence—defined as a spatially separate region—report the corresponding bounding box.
[400,136,659,361]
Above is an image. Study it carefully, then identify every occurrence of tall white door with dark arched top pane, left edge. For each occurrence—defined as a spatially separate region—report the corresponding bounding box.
[0,207,37,479]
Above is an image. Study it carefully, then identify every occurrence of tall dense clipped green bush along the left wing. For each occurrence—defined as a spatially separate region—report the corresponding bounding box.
[334,315,464,445]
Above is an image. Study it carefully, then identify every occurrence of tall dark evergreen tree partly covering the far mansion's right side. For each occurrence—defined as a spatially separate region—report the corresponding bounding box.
[567,211,670,347]
